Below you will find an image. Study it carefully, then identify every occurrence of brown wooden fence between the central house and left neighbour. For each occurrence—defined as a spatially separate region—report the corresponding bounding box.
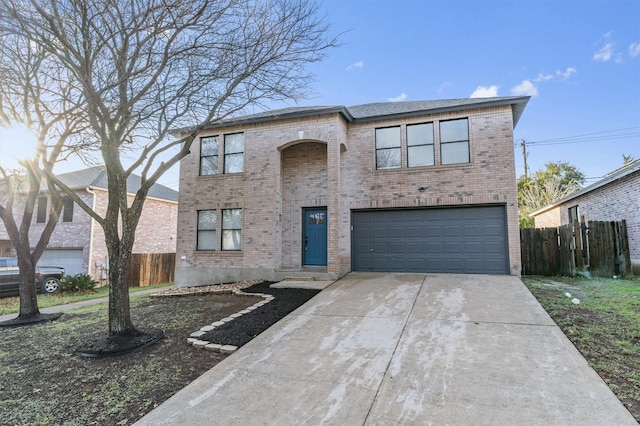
[129,253,176,287]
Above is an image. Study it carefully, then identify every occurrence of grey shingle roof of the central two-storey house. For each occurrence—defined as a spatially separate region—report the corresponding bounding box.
[194,96,530,134]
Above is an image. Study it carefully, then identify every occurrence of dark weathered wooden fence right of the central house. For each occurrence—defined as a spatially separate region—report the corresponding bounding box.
[520,220,631,277]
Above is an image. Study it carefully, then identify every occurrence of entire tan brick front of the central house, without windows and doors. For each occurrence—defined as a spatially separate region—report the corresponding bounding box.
[176,99,520,285]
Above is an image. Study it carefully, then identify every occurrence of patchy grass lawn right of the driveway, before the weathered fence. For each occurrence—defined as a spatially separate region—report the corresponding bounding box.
[522,277,640,422]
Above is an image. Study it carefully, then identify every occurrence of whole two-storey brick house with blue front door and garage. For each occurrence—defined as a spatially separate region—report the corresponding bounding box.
[175,97,529,285]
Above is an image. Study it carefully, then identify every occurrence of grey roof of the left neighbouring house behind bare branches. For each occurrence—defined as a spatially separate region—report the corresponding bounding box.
[57,166,178,202]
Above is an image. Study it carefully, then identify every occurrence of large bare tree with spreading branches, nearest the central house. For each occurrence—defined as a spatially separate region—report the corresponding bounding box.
[0,0,336,342]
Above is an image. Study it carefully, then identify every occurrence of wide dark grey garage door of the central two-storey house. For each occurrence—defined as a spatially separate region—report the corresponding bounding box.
[351,206,509,274]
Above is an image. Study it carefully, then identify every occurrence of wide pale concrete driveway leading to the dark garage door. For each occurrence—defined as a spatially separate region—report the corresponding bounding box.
[138,273,637,426]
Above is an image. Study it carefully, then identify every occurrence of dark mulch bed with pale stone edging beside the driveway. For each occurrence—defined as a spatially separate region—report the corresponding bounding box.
[199,282,320,347]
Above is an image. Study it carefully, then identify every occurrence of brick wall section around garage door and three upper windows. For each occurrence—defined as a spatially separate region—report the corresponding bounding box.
[341,106,520,274]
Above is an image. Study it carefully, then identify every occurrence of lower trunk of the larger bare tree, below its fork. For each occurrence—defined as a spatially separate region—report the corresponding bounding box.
[105,230,138,336]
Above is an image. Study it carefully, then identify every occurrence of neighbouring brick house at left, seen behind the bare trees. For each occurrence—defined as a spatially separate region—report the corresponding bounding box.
[0,166,178,279]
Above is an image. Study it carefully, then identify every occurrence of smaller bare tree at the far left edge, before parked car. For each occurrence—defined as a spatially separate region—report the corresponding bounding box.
[0,30,81,321]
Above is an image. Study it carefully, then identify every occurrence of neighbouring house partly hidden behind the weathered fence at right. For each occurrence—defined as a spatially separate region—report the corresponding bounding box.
[531,159,640,274]
